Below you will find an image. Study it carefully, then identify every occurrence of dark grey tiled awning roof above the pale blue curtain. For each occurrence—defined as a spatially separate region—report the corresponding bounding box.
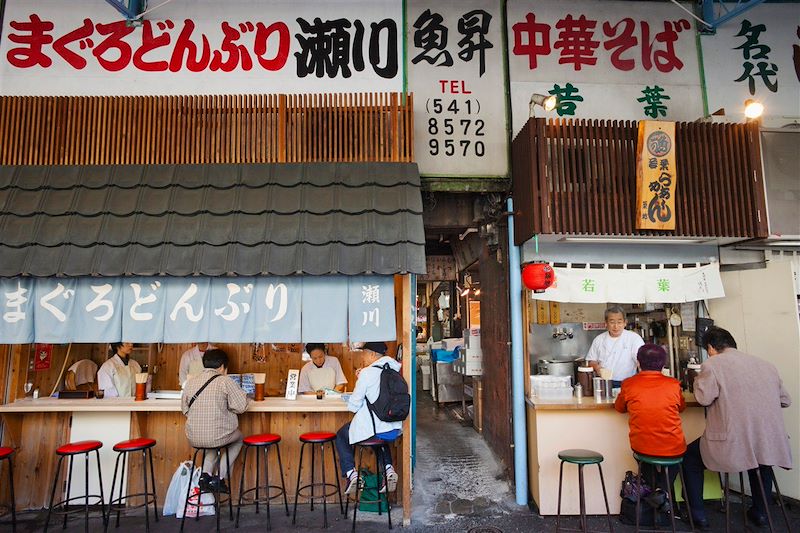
[0,163,425,277]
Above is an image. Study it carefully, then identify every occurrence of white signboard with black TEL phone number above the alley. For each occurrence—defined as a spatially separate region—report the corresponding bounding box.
[406,0,508,177]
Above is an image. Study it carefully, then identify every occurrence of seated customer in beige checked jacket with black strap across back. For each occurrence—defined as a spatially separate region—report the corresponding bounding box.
[181,349,247,493]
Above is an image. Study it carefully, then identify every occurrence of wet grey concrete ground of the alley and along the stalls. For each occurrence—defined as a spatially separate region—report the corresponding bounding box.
[7,380,800,533]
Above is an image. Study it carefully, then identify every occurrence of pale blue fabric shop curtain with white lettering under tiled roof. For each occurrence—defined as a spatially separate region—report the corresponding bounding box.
[0,276,396,344]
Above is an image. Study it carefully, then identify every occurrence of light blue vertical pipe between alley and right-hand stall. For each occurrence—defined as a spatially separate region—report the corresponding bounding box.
[507,198,528,505]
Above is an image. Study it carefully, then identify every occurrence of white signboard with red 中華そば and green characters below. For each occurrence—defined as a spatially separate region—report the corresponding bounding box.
[508,0,703,135]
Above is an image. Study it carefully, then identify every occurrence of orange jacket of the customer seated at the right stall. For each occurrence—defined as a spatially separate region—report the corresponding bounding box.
[614,370,686,457]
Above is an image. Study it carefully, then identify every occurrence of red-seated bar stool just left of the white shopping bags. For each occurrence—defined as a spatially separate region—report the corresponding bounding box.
[105,438,158,532]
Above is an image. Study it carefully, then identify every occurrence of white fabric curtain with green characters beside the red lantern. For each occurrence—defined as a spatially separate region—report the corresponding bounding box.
[531,263,725,304]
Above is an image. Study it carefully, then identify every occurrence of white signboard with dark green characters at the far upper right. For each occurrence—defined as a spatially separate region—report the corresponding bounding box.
[700,4,800,127]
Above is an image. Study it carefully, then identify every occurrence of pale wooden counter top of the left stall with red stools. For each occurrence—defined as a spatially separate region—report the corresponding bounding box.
[0,395,347,413]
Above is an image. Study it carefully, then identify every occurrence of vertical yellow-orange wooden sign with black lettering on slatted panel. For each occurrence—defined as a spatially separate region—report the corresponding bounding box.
[636,120,677,230]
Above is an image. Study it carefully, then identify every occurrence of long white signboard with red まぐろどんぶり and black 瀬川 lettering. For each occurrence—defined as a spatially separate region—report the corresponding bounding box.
[0,0,403,95]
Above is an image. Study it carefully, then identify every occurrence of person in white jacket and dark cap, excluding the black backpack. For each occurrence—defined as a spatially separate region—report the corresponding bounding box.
[336,342,403,495]
